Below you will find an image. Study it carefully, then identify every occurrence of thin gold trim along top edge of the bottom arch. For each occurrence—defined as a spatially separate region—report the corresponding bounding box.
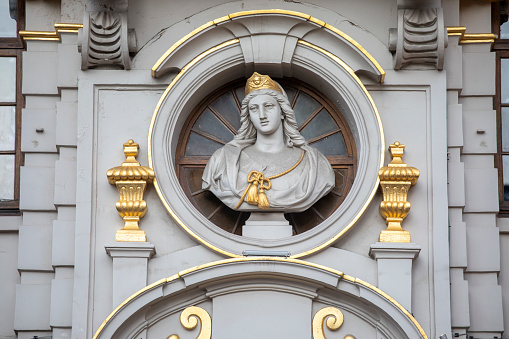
[92,257,428,339]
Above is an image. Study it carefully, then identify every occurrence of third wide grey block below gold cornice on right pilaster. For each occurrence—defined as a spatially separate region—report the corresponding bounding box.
[465,168,498,212]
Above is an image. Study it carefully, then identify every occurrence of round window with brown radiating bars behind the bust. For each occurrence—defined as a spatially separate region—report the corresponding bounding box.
[175,79,357,235]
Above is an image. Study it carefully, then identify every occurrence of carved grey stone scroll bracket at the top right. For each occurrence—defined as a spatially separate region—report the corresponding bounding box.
[389,8,447,70]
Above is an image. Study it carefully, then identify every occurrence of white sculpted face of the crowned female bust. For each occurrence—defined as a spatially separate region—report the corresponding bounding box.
[248,94,283,135]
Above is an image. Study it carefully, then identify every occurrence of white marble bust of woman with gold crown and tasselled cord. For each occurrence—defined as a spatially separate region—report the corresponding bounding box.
[202,72,334,212]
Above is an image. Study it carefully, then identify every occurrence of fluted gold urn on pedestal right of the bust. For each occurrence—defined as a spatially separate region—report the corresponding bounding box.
[378,141,419,242]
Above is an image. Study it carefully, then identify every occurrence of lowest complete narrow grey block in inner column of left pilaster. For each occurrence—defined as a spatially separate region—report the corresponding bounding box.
[50,279,74,327]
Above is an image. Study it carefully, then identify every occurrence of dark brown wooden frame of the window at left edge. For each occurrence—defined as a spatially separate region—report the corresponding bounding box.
[0,0,25,215]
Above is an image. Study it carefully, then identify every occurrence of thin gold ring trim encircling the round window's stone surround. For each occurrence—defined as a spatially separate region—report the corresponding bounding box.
[147,39,385,258]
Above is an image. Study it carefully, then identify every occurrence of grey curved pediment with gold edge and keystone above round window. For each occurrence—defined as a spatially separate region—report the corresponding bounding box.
[152,9,385,82]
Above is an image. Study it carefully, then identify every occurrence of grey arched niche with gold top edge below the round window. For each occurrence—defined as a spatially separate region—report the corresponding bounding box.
[93,257,427,339]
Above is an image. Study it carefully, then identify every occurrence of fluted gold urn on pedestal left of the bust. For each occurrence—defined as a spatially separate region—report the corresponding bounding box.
[106,140,155,242]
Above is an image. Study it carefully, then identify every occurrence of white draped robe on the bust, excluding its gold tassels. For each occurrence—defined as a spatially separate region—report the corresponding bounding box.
[202,142,335,212]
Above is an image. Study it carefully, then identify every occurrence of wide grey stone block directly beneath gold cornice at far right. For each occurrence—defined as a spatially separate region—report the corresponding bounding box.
[461,53,495,96]
